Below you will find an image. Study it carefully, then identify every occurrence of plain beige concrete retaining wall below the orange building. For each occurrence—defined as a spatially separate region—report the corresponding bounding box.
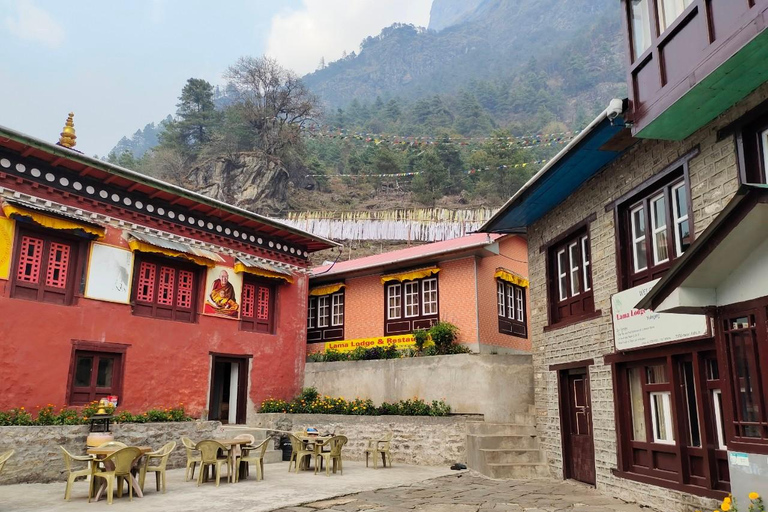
[304,354,533,422]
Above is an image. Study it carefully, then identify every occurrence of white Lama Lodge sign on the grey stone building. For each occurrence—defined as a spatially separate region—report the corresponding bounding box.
[611,279,709,350]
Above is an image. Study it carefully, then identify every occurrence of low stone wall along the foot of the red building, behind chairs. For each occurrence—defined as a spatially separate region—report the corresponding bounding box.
[0,421,221,484]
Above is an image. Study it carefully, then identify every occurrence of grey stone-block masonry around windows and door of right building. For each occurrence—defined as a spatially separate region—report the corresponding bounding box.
[528,80,768,511]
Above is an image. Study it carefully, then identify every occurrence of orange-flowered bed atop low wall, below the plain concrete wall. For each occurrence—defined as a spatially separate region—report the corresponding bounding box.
[259,388,451,416]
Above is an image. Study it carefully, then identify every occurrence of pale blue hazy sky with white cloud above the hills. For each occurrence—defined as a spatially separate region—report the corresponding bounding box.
[0,0,432,156]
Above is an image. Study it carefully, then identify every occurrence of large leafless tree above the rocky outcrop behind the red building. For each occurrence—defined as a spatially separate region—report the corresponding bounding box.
[225,57,320,156]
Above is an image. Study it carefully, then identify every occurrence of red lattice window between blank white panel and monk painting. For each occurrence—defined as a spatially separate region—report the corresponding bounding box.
[131,252,201,322]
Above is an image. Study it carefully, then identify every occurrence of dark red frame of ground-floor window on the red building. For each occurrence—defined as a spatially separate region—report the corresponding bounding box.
[67,342,127,405]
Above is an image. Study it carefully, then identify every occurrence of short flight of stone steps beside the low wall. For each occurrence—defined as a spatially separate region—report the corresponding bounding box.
[467,414,550,480]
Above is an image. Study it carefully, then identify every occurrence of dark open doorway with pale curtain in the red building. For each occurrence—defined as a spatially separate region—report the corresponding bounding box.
[208,355,248,425]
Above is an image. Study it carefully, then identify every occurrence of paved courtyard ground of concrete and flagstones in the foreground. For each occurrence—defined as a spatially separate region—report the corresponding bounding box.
[0,462,647,512]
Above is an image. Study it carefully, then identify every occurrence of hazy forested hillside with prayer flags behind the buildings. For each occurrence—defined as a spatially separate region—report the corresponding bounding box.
[109,0,625,215]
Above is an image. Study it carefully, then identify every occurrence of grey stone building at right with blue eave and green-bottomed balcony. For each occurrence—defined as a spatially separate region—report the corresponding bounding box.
[483,0,768,511]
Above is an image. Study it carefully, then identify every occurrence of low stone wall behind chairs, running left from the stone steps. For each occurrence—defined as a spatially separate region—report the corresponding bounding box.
[251,413,471,466]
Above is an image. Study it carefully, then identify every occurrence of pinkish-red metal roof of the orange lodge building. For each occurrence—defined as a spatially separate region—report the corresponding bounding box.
[312,233,504,276]
